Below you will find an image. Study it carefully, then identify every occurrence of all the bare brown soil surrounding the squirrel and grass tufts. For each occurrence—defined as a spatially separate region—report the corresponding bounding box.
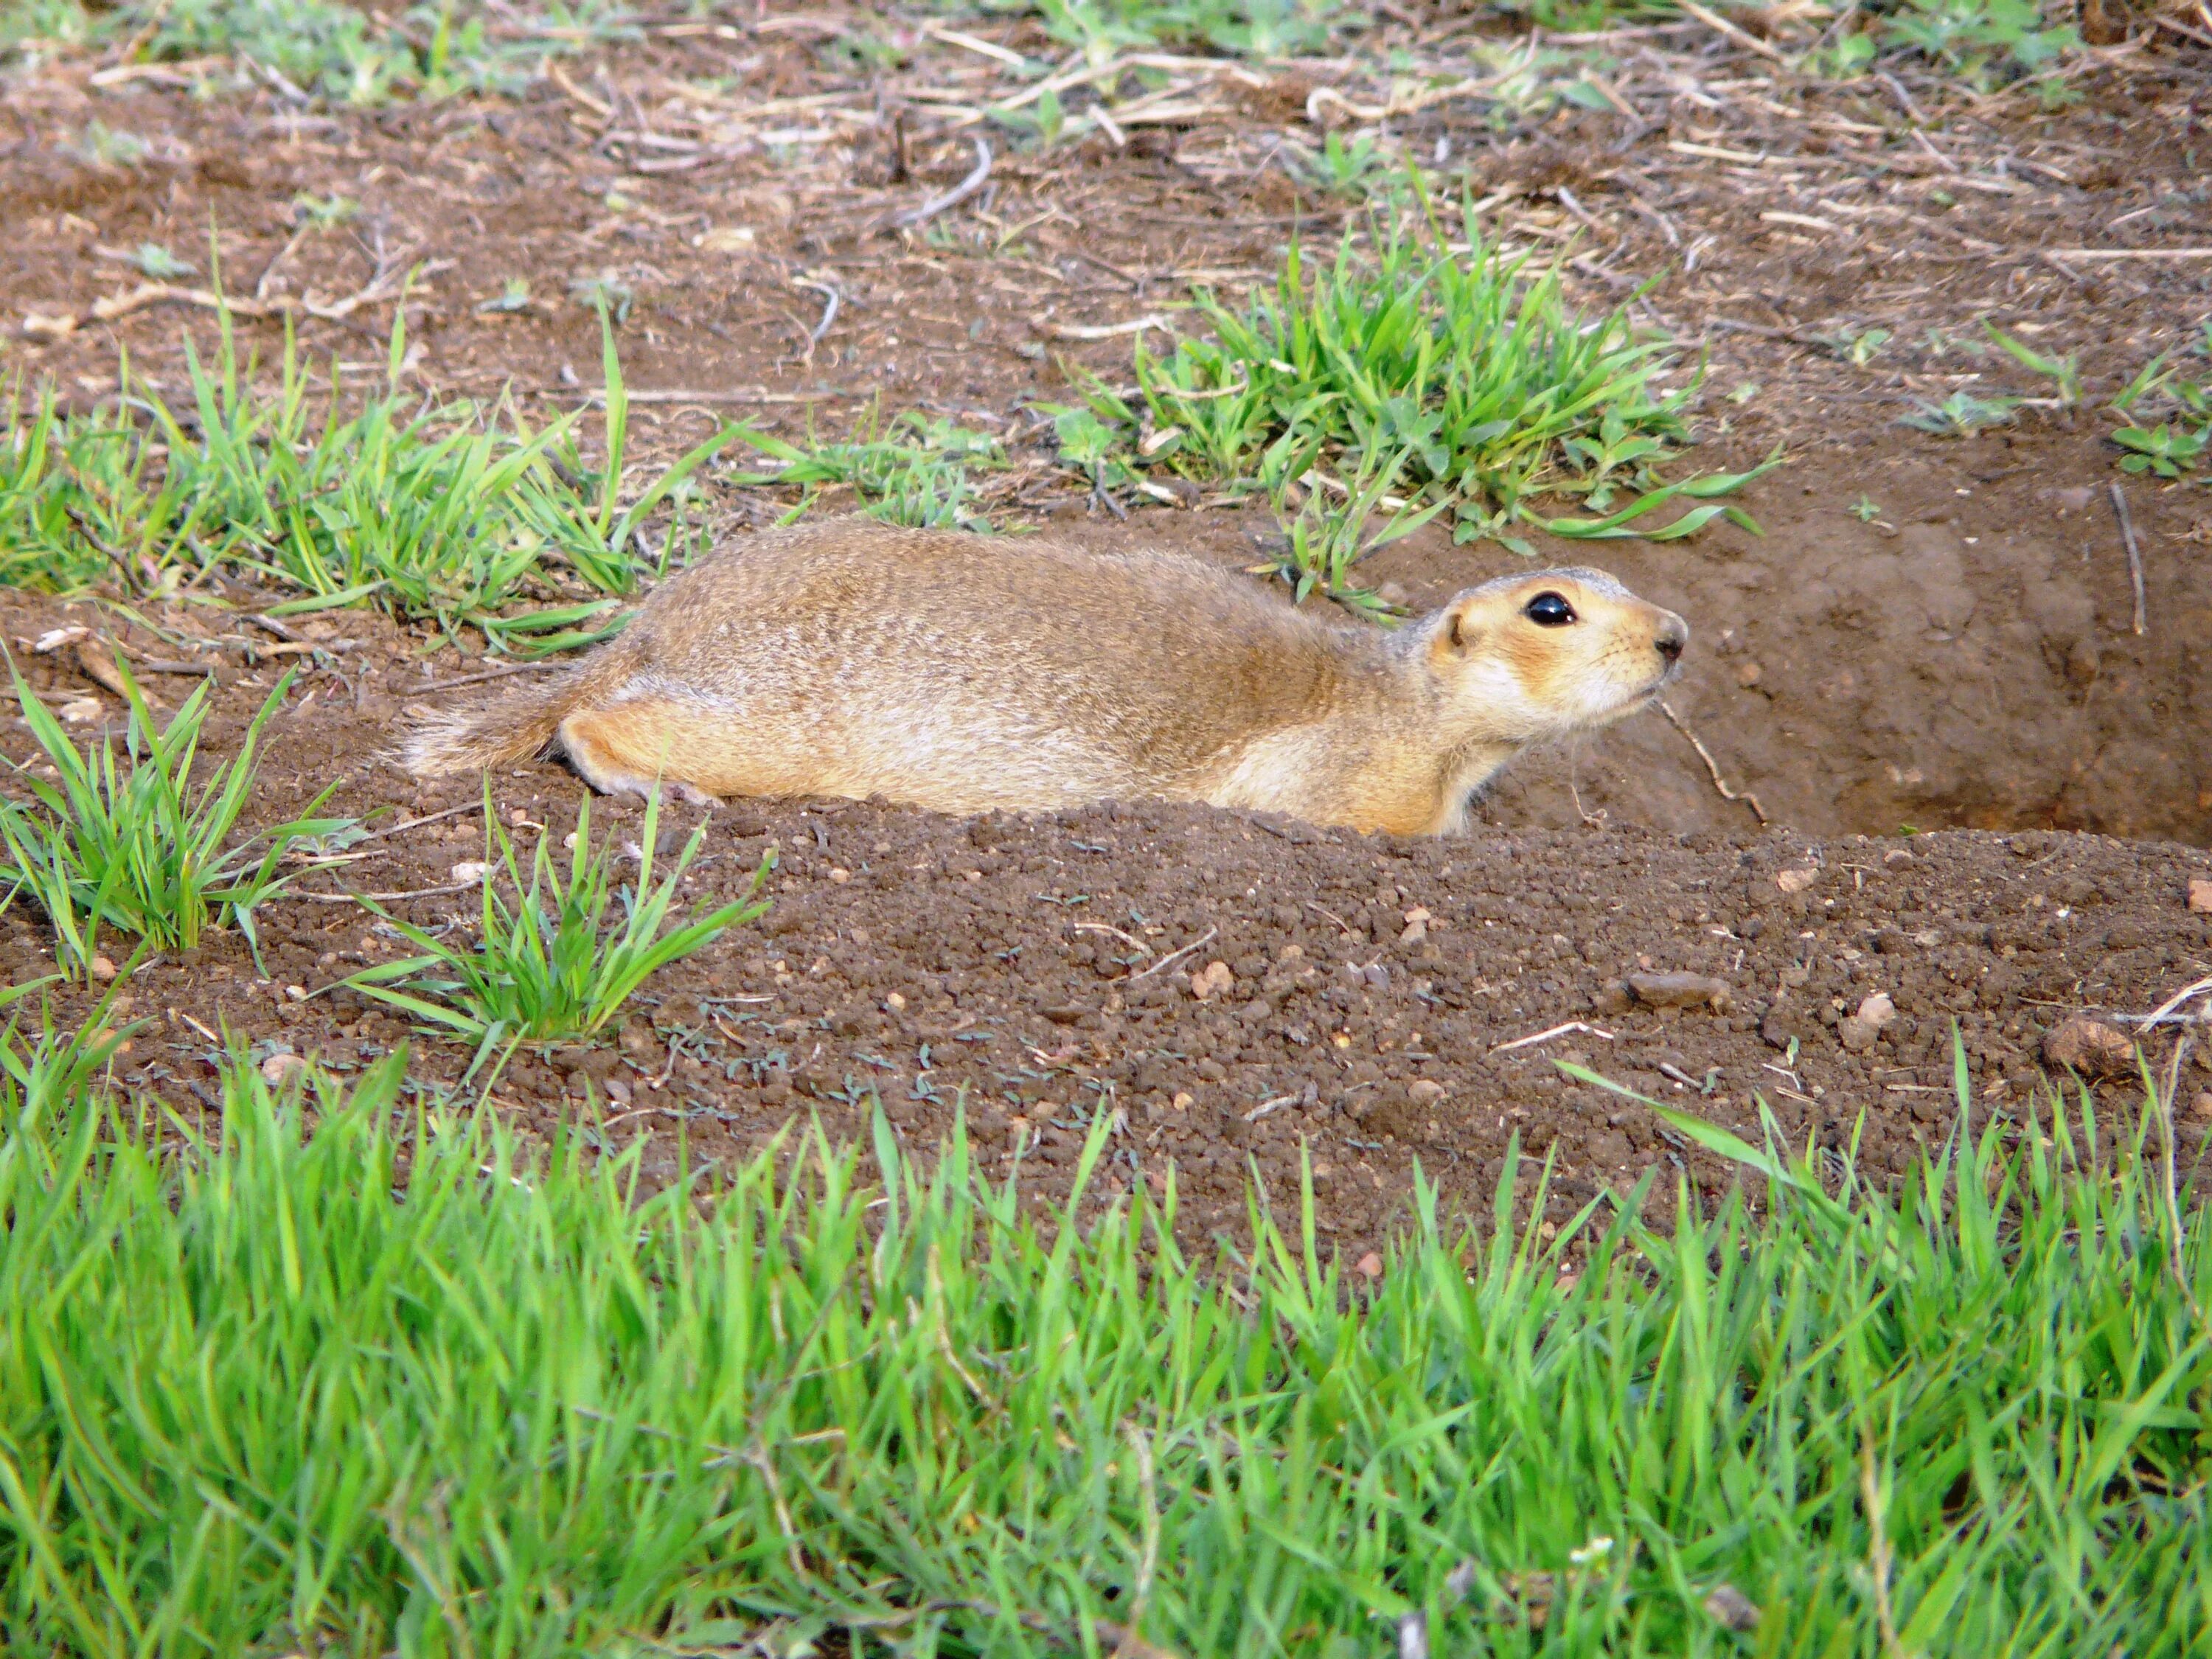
[0,9,2212,1250]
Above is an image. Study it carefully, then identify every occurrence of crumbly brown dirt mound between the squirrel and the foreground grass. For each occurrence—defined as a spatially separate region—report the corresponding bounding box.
[0,604,2212,1256]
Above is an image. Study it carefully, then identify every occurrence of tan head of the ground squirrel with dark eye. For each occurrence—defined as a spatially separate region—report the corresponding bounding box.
[1407,568,1690,745]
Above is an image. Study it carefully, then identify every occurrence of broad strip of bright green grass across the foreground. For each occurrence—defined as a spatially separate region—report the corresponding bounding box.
[0,1040,2212,1659]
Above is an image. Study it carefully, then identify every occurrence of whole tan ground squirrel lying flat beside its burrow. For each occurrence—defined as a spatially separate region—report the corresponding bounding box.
[405,520,1690,834]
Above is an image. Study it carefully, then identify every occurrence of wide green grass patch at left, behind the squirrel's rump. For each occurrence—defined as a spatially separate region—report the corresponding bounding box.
[0,314,737,655]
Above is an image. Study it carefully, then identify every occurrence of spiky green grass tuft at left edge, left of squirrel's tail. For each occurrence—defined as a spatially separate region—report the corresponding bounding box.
[0,657,347,975]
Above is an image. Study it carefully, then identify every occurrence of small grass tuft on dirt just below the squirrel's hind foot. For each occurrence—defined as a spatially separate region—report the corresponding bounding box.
[341,781,774,1075]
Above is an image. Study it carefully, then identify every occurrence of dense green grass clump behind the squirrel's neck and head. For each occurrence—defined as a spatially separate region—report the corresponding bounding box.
[1062,187,1772,553]
